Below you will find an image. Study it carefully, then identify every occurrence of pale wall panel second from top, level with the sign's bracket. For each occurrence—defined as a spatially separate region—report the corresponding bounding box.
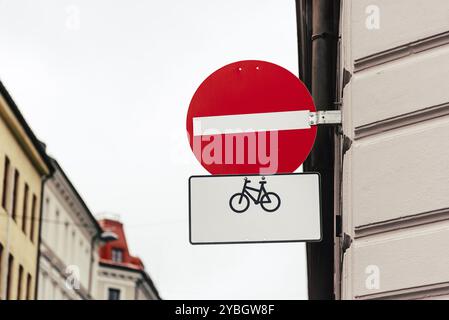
[352,44,449,127]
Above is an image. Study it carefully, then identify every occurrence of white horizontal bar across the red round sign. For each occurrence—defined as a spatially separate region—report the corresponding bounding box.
[193,110,310,136]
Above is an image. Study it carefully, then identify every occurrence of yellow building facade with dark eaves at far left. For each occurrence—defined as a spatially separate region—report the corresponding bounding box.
[0,82,51,300]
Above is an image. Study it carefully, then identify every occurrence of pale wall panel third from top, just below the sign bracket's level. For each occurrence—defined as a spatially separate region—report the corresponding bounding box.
[352,116,449,226]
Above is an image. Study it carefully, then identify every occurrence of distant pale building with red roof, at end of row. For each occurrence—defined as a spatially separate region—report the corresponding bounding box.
[97,218,160,300]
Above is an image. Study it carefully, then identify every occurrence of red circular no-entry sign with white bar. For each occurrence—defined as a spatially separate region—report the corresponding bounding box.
[187,60,317,174]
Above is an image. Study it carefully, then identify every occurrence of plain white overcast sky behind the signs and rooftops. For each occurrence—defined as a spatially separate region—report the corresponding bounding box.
[0,0,307,299]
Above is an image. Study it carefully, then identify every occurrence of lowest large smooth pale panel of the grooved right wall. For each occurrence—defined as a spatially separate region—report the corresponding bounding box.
[353,221,449,298]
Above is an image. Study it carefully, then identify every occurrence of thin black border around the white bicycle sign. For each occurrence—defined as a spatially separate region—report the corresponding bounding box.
[189,172,323,246]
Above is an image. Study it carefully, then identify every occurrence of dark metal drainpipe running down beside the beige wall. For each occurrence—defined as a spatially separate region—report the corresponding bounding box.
[297,0,340,300]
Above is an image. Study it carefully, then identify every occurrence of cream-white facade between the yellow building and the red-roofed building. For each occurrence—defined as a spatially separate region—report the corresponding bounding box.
[38,160,102,300]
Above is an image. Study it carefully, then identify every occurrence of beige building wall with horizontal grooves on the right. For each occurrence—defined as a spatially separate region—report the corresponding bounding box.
[340,0,449,299]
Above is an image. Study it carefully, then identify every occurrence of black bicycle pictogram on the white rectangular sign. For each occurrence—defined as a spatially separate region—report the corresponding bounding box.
[229,177,281,213]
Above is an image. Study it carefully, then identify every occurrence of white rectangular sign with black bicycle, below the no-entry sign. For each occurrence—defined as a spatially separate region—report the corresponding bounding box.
[189,173,321,244]
